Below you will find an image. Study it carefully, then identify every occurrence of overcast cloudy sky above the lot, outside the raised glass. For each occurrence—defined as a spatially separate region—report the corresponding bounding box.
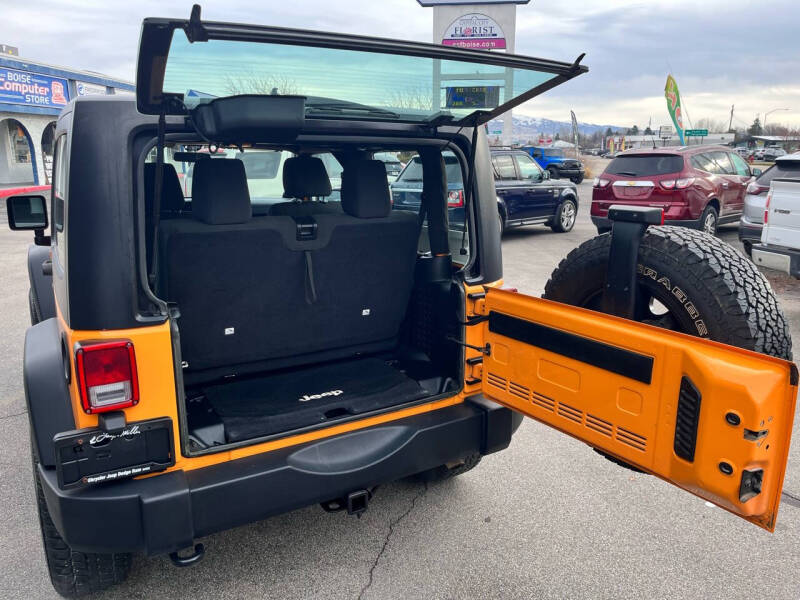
[0,0,800,127]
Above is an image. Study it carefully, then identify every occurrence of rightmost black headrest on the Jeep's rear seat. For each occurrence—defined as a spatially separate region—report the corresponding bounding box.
[342,160,392,219]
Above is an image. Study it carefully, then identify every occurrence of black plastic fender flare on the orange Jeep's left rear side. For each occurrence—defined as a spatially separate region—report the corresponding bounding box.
[22,318,75,467]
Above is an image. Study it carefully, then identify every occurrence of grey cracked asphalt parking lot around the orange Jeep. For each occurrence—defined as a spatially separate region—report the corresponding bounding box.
[0,182,800,599]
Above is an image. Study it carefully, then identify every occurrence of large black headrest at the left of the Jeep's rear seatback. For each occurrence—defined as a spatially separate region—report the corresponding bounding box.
[192,158,253,225]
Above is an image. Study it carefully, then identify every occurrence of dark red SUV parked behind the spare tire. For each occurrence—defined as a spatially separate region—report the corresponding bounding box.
[591,146,753,234]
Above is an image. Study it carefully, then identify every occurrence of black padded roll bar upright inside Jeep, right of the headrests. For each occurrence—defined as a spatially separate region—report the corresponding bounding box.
[419,147,450,256]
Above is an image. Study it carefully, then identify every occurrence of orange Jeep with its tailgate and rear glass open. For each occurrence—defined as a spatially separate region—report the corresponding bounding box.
[7,7,797,596]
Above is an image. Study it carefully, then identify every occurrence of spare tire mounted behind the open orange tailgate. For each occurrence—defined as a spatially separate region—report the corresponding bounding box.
[544,226,792,360]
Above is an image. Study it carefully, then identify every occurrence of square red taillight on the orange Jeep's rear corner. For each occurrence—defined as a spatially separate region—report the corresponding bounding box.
[75,340,139,414]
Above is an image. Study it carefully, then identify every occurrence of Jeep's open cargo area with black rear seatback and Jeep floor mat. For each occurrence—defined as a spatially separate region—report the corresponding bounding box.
[145,144,464,452]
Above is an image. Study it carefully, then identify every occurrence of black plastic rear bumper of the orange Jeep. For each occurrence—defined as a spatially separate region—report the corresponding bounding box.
[39,396,522,555]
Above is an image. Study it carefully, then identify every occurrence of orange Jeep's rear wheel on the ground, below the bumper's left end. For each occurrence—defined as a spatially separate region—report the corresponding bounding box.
[32,456,131,598]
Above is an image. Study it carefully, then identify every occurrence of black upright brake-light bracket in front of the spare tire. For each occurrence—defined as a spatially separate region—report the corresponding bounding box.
[602,204,664,319]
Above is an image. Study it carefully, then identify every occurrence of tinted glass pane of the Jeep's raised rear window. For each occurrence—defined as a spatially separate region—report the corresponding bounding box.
[163,30,556,121]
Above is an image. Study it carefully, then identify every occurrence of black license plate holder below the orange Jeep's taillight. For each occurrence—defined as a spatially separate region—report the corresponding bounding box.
[53,417,175,489]
